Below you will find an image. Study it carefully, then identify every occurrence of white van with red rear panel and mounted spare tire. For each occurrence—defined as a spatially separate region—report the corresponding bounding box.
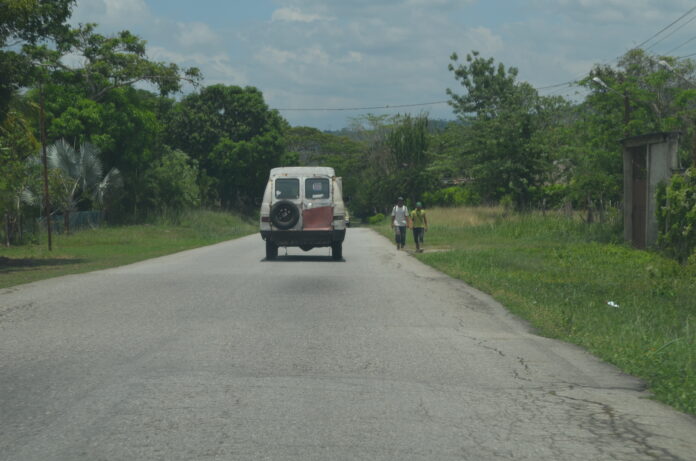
[260,166,346,260]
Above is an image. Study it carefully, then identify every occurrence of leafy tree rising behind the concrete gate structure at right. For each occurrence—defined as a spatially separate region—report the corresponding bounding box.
[564,49,696,214]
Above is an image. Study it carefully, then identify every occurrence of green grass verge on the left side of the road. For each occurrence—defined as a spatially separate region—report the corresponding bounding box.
[0,211,258,288]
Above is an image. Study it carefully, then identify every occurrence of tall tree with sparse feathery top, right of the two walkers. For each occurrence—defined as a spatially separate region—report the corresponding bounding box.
[447,51,558,209]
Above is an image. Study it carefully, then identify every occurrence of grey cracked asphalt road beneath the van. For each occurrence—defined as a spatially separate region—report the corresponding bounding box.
[0,229,696,461]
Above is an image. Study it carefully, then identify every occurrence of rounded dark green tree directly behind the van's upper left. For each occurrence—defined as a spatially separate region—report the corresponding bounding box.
[166,85,288,209]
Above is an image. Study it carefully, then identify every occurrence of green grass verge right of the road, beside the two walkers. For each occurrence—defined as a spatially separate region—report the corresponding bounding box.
[379,209,696,414]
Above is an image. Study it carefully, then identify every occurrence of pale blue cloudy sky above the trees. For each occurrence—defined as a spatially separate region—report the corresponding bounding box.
[71,0,696,130]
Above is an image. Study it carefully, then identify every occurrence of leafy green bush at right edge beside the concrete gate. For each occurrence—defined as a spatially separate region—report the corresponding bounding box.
[657,168,696,263]
